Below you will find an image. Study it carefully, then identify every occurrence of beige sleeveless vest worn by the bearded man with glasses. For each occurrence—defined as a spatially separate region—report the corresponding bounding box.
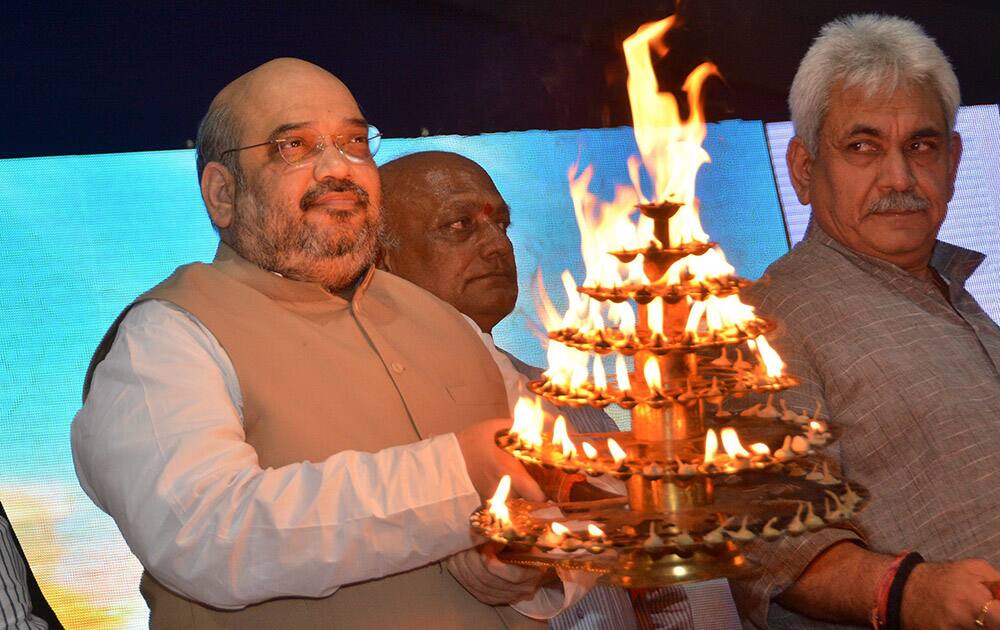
[84,245,544,630]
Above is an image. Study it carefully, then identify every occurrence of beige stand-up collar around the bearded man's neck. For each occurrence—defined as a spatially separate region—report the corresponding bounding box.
[212,241,378,307]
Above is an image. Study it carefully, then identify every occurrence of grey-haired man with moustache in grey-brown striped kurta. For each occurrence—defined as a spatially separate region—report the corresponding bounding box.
[734,15,1000,628]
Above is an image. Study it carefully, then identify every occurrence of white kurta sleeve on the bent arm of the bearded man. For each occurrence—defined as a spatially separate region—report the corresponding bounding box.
[72,301,479,609]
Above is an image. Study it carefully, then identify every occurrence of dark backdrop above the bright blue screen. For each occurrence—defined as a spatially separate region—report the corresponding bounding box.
[0,0,1000,157]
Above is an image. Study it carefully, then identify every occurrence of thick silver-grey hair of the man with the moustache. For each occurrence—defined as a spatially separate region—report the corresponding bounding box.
[788,14,961,155]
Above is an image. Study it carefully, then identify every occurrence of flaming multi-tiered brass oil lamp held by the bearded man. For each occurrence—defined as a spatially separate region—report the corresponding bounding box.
[471,18,869,587]
